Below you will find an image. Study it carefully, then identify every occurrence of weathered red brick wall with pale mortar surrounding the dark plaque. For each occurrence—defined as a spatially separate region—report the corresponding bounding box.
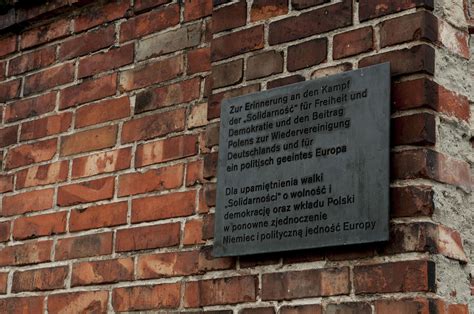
[0,0,474,314]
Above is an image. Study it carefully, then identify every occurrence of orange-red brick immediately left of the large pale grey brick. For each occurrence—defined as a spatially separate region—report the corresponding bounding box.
[78,44,134,78]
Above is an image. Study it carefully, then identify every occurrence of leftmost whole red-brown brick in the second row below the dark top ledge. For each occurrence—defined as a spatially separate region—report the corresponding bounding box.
[8,46,56,75]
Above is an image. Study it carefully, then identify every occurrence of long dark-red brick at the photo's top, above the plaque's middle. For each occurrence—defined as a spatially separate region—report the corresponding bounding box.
[269,0,352,45]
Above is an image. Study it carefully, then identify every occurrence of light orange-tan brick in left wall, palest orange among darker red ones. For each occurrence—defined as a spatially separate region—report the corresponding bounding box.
[60,125,117,156]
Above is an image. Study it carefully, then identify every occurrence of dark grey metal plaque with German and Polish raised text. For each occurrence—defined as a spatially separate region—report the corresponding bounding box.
[214,64,390,256]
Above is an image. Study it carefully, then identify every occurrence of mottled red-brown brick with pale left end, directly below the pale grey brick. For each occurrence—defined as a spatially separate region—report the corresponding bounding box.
[120,55,184,91]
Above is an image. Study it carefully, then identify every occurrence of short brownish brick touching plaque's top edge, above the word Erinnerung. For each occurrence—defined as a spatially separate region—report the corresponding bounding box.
[247,50,283,80]
